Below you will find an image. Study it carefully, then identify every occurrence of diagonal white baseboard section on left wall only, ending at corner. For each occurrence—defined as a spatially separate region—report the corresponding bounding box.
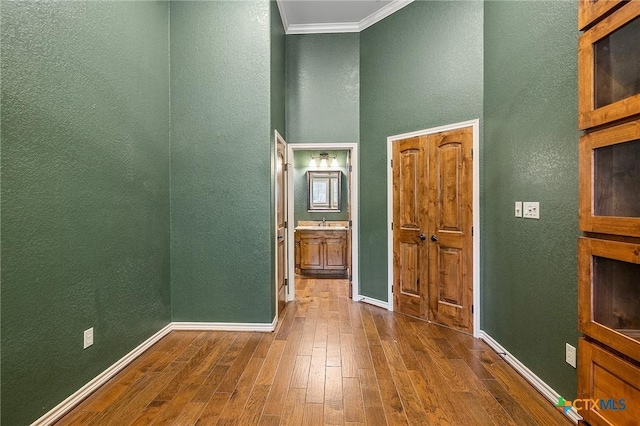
[31,324,172,426]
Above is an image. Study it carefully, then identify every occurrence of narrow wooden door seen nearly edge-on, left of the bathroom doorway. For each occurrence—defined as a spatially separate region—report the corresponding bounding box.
[276,137,287,316]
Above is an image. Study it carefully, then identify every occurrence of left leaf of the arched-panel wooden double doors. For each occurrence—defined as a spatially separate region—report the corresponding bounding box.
[392,136,429,319]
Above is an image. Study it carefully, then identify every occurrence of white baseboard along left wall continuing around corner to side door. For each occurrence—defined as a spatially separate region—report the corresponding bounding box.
[31,317,278,426]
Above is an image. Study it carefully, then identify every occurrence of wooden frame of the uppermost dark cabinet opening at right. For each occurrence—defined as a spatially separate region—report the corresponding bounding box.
[578,1,640,130]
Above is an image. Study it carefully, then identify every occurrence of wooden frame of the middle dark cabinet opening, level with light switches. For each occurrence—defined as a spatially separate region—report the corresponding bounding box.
[579,120,640,237]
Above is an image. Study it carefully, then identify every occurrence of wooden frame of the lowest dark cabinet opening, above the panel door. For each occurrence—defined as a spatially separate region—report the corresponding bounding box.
[578,238,640,360]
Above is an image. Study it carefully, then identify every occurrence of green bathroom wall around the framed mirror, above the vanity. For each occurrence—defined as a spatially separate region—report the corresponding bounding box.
[291,150,349,225]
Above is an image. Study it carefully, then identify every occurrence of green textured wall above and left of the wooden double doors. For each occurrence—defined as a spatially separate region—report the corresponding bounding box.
[359,1,483,301]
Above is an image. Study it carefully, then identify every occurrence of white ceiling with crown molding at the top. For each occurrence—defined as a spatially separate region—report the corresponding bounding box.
[278,0,413,34]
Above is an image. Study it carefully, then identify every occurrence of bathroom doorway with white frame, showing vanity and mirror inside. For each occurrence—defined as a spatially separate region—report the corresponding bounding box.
[286,144,360,301]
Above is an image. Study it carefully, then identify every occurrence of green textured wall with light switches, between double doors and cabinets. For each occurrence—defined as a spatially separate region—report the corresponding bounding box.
[481,1,579,399]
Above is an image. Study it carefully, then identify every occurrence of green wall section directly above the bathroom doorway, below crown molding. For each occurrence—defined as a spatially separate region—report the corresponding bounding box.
[286,33,360,143]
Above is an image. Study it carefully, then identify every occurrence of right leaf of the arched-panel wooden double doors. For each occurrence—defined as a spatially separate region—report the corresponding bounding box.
[428,127,473,333]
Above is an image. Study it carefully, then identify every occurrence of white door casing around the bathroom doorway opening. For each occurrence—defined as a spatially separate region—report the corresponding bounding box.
[287,143,360,301]
